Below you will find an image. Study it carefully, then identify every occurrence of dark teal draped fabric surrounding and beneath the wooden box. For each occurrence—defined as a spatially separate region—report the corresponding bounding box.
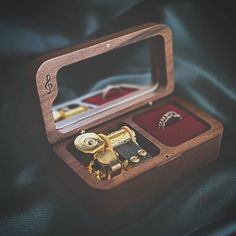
[0,0,236,235]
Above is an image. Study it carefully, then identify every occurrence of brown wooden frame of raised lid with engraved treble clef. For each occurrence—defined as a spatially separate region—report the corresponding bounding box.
[36,23,174,143]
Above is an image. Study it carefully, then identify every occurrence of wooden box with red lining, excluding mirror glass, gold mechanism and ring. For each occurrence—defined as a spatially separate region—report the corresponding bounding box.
[36,23,223,214]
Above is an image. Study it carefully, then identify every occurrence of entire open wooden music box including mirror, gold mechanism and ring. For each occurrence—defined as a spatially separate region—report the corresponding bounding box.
[36,23,223,214]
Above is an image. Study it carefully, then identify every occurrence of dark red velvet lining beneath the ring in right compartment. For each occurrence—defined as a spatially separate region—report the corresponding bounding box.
[134,103,209,146]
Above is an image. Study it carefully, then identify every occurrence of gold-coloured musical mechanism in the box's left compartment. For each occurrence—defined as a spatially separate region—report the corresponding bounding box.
[74,126,151,180]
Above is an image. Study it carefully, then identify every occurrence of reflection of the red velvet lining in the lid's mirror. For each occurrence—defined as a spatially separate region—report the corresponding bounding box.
[83,87,137,105]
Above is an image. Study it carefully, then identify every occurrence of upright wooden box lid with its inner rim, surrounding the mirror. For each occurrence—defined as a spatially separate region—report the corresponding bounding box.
[36,23,174,143]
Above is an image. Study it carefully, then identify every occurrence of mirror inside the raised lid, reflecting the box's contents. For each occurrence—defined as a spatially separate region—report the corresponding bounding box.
[53,40,152,128]
